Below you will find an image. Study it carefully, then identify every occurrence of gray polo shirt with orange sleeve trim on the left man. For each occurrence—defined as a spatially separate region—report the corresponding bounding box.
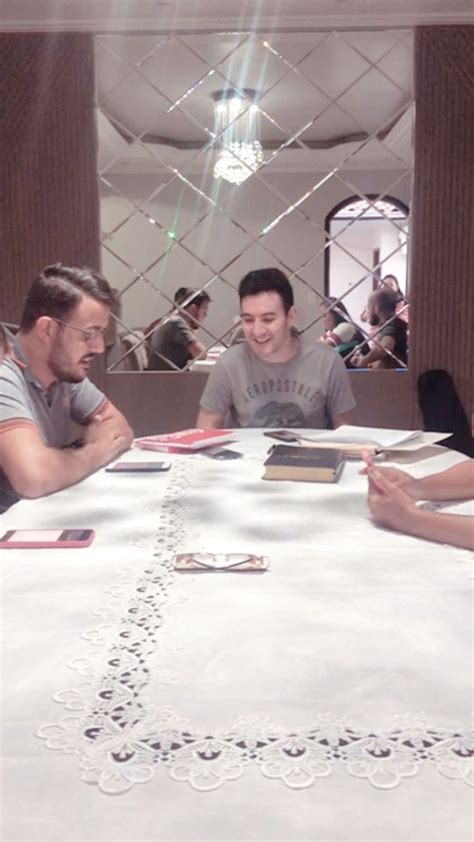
[0,331,106,512]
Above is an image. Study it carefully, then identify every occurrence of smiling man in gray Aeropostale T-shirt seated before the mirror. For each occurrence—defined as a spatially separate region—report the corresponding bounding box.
[197,268,355,429]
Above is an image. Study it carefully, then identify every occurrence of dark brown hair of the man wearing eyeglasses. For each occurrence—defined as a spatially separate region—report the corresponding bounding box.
[20,263,115,333]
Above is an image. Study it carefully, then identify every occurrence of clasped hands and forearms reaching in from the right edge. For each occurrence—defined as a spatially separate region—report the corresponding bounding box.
[361,452,474,550]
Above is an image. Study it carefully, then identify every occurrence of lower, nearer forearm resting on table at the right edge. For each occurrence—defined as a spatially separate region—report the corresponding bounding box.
[403,506,474,550]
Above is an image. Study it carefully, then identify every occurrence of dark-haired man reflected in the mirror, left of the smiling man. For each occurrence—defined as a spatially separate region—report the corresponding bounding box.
[147,287,211,371]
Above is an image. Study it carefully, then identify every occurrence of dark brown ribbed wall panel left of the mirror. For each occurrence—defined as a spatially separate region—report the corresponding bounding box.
[0,33,100,322]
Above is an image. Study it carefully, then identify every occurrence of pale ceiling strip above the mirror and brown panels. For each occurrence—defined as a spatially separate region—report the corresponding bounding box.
[0,0,474,31]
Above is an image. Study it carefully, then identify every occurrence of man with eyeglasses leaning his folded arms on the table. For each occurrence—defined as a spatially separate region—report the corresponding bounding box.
[0,263,133,512]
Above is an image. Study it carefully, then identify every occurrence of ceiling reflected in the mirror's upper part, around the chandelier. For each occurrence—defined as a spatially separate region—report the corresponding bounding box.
[96,29,413,174]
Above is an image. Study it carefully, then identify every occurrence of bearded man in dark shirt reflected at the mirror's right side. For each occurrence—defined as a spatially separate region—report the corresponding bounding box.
[350,288,407,369]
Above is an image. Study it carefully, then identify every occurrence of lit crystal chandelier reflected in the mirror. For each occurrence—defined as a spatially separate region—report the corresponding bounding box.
[213,89,263,184]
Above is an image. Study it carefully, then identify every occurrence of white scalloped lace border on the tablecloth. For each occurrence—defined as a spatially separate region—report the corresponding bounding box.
[37,461,474,794]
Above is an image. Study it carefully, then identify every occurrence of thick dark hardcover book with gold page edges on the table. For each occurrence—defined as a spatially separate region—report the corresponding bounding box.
[263,444,344,482]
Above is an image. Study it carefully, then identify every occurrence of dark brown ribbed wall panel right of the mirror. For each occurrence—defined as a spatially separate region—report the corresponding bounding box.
[410,26,474,416]
